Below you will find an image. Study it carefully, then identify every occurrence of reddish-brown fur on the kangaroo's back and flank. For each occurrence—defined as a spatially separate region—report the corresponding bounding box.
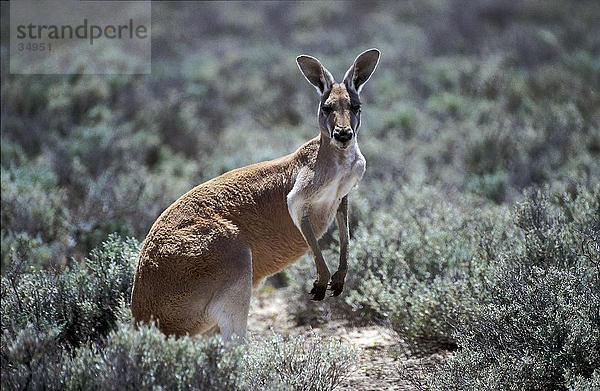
[132,137,326,334]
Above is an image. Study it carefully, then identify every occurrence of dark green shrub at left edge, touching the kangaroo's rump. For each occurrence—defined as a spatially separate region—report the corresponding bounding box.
[1,235,139,348]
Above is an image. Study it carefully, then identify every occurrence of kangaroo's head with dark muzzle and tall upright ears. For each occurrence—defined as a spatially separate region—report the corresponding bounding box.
[296,49,380,149]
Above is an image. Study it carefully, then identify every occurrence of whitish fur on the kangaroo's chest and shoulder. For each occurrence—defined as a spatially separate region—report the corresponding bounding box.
[287,143,366,237]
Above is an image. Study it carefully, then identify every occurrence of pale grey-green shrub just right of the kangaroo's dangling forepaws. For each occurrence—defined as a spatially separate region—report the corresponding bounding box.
[291,185,502,347]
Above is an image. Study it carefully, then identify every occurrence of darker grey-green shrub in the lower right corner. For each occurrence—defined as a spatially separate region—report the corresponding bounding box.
[422,187,600,390]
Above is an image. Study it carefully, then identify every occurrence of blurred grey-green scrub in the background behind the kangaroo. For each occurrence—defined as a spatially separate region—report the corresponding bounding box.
[0,1,600,266]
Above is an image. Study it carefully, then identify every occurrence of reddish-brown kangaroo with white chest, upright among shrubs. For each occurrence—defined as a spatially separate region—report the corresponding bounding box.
[131,49,380,340]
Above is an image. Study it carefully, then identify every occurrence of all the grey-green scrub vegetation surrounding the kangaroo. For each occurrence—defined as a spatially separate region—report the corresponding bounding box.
[0,0,600,390]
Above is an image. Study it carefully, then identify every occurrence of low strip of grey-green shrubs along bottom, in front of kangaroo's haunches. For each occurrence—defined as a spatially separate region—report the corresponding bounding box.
[2,320,355,390]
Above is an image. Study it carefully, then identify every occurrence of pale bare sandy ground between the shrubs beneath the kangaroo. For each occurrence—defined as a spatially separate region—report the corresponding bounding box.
[248,289,448,391]
